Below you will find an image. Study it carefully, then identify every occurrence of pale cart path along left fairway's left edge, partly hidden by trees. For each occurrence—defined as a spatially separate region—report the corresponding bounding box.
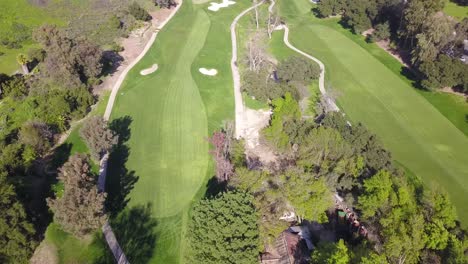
[98,0,183,264]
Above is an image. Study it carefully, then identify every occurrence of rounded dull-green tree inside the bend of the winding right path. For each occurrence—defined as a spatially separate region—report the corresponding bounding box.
[277,56,320,86]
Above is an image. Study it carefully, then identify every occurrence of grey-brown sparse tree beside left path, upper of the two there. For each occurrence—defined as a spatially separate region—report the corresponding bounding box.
[80,116,118,161]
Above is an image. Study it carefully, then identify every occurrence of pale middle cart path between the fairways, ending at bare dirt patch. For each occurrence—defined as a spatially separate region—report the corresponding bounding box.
[231,0,265,139]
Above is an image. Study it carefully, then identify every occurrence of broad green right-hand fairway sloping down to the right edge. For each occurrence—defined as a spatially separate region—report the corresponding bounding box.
[281,0,468,225]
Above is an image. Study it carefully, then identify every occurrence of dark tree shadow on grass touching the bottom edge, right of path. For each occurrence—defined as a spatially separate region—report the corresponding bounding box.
[110,203,158,263]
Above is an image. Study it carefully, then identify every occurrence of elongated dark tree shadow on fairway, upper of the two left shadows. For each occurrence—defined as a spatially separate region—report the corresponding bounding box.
[106,116,138,217]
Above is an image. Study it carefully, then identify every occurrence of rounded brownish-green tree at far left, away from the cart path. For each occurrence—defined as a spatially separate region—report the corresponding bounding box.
[19,121,52,156]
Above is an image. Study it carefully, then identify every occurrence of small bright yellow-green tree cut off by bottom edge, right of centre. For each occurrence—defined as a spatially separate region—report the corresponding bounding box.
[312,239,351,264]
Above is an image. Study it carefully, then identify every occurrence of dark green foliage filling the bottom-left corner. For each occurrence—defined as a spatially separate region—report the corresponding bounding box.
[0,172,36,263]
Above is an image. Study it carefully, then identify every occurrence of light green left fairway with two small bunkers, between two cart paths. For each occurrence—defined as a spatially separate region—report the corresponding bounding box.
[108,0,249,263]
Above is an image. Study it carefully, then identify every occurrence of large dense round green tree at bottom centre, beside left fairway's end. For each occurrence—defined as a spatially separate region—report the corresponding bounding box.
[186,192,259,264]
